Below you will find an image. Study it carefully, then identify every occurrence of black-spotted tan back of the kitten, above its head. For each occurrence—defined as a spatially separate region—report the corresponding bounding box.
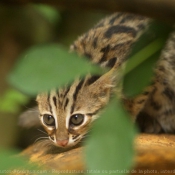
[71,13,150,67]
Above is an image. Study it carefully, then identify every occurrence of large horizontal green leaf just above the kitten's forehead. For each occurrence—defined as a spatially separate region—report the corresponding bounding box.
[9,44,101,95]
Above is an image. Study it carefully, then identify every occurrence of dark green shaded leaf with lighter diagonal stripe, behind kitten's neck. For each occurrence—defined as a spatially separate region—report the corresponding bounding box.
[123,22,172,97]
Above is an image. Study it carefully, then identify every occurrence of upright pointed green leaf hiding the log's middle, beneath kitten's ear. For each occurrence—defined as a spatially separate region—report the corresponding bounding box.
[86,100,136,175]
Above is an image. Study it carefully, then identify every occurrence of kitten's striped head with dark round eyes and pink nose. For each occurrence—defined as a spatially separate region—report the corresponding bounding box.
[37,71,114,148]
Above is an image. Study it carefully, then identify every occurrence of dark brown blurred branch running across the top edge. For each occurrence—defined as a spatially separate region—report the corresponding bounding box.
[0,0,175,22]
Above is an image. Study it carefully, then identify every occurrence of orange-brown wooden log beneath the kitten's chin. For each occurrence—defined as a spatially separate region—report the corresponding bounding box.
[8,134,175,175]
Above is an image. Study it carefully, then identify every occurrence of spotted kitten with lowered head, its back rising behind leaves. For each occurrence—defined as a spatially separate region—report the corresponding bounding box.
[37,13,150,147]
